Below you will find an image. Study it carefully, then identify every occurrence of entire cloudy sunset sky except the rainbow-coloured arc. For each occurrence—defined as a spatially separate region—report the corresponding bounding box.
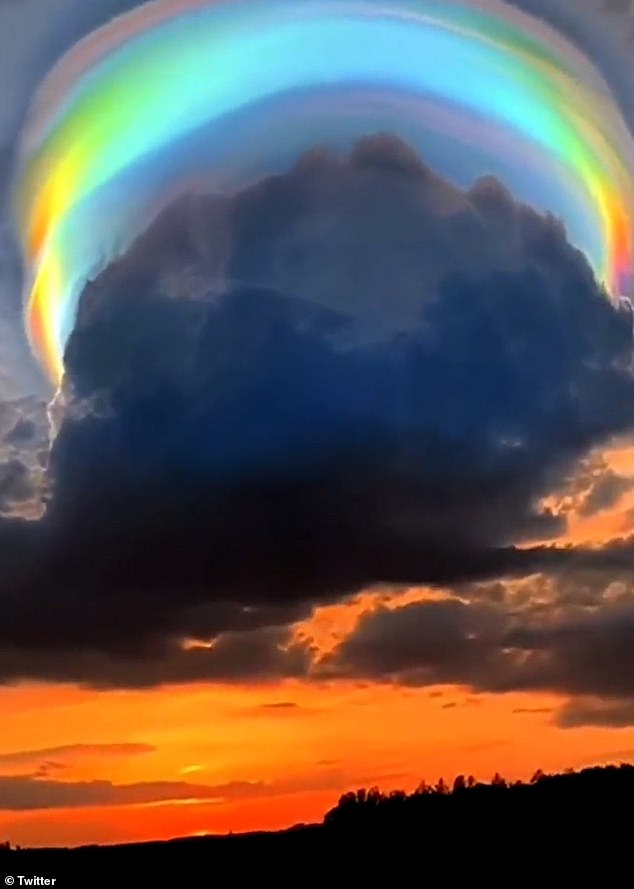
[0,0,634,845]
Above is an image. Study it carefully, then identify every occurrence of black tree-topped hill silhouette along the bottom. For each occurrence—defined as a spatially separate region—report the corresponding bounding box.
[0,764,634,887]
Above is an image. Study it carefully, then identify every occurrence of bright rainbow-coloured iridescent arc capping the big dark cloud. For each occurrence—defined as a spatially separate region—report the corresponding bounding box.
[15,0,634,385]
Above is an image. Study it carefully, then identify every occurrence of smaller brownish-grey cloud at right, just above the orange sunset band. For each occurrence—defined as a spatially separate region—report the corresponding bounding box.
[318,593,634,727]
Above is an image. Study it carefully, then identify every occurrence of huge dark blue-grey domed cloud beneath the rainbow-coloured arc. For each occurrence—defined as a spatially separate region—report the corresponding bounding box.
[0,137,634,685]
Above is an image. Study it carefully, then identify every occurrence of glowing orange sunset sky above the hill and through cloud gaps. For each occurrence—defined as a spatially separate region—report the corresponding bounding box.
[0,462,634,845]
